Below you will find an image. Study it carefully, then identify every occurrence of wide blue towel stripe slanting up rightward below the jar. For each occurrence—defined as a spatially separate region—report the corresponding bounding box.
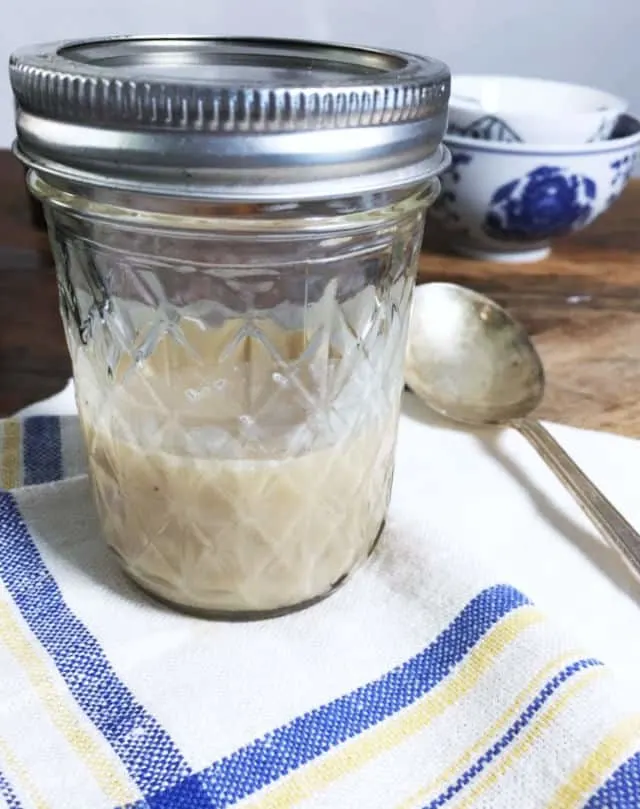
[131,585,529,809]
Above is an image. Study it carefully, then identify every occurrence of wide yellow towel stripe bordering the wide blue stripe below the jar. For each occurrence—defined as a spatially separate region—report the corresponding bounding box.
[245,606,545,809]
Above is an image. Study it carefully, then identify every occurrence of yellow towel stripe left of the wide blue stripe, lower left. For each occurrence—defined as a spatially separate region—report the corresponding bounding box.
[0,602,139,806]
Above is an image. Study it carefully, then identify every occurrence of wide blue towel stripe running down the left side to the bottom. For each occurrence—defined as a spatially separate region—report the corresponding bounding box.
[0,492,210,807]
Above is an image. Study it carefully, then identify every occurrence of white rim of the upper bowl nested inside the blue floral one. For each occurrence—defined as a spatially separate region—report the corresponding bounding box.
[449,73,629,120]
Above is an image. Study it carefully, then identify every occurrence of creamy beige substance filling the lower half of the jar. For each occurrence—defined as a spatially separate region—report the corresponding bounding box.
[75,322,397,613]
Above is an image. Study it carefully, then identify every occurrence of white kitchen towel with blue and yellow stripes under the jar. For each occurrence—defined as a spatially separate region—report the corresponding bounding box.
[0,404,640,809]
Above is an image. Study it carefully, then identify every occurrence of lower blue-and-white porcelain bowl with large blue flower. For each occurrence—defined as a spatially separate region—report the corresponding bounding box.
[430,115,640,262]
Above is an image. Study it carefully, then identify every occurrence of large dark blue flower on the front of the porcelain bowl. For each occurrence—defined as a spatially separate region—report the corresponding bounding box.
[482,166,596,242]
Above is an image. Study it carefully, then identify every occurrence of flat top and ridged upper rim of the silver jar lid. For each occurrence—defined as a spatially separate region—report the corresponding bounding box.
[9,36,451,132]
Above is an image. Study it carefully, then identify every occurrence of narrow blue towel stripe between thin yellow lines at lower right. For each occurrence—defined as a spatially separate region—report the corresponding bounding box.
[424,657,602,809]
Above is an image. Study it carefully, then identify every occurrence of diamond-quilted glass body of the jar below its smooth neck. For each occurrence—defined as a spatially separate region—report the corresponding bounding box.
[53,208,422,612]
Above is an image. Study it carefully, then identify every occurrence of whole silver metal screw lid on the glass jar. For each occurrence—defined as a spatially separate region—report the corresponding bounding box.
[9,37,450,200]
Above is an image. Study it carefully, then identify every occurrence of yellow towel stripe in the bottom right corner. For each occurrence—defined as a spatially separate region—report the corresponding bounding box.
[549,714,640,809]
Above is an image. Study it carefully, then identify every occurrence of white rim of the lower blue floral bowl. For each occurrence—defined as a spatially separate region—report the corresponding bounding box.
[443,113,640,157]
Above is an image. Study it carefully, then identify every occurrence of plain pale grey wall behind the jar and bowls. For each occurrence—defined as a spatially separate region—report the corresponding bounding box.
[0,0,640,147]
